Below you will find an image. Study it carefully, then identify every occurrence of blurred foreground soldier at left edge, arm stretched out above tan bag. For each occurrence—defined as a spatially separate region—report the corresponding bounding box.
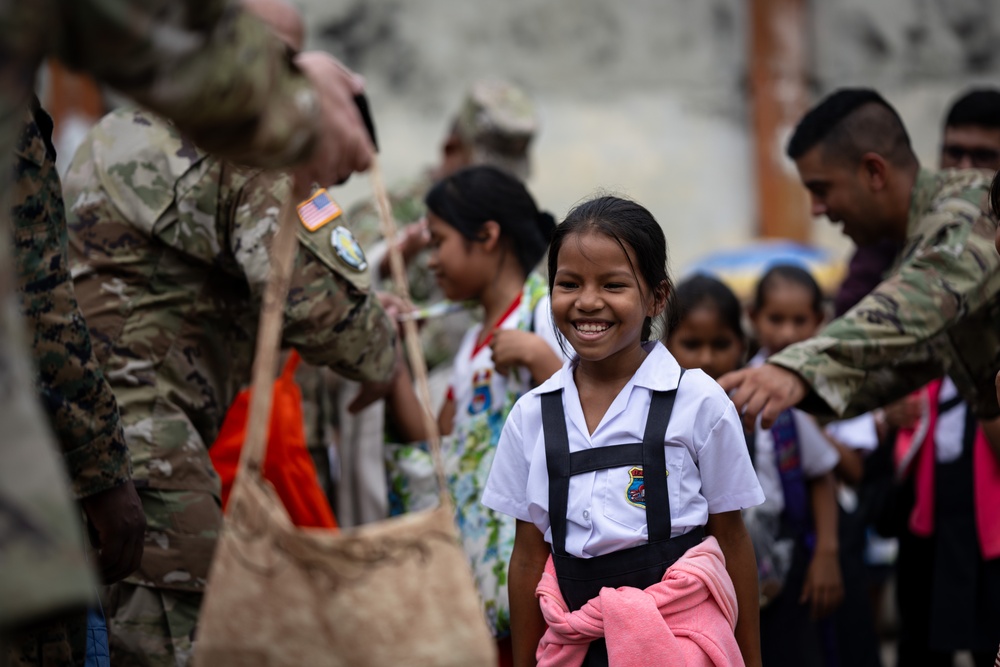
[0,0,371,660]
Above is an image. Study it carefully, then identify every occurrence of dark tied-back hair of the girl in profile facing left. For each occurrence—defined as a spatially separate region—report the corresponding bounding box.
[424,165,556,276]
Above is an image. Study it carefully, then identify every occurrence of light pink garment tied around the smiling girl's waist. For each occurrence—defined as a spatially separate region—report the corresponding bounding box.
[535,537,744,667]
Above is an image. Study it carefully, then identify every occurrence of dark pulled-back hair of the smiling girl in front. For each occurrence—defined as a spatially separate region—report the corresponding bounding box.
[549,196,674,342]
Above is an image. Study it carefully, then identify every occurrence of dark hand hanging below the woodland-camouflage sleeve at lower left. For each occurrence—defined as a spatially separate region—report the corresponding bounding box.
[80,480,146,584]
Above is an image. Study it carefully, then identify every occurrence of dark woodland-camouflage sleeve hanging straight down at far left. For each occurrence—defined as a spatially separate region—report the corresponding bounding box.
[11,105,131,498]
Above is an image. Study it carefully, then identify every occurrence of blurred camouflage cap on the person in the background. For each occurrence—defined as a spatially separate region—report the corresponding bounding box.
[454,80,538,180]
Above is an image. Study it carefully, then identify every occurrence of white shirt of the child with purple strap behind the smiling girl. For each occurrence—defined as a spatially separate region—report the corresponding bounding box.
[747,350,840,513]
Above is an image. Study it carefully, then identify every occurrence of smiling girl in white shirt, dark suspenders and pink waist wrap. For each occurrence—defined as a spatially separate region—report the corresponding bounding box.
[483,197,763,666]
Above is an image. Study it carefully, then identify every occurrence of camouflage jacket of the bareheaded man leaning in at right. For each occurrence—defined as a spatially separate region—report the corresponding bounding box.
[768,170,1000,418]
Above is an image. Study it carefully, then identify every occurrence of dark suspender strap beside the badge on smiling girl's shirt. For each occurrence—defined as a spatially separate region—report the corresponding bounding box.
[642,369,684,542]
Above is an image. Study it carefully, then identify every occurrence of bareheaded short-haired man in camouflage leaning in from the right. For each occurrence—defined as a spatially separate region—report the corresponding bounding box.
[720,89,1000,438]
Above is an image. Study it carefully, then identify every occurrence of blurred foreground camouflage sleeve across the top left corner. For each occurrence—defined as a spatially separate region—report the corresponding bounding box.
[48,0,319,167]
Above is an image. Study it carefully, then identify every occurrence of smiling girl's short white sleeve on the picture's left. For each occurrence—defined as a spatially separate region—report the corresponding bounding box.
[481,401,531,521]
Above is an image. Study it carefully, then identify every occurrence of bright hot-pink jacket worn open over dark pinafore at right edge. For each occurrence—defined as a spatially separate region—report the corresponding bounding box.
[897,380,1000,560]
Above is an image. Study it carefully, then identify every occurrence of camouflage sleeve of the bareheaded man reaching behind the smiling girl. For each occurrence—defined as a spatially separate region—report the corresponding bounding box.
[768,200,1000,417]
